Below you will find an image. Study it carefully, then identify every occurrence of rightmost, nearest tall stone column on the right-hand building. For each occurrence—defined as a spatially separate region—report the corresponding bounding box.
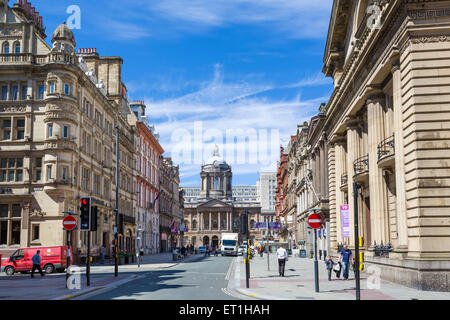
[392,62,408,252]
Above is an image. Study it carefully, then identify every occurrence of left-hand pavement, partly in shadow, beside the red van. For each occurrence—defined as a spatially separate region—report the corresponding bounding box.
[0,253,203,300]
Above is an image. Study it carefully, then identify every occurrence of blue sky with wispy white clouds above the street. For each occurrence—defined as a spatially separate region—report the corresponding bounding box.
[29,0,333,187]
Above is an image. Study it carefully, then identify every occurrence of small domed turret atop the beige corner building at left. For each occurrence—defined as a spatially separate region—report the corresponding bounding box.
[50,22,76,63]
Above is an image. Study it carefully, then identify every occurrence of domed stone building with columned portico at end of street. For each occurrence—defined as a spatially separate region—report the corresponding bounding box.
[184,146,261,247]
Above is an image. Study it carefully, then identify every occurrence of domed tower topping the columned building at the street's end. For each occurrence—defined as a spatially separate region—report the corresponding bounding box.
[200,145,233,200]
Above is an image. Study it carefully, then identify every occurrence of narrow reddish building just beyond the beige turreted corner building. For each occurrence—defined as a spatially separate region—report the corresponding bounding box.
[131,101,164,254]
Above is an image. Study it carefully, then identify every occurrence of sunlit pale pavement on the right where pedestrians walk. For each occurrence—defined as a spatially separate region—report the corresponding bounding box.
[227,254,450,300]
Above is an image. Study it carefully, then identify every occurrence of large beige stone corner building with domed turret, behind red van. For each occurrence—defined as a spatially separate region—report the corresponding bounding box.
[0,1,135,262]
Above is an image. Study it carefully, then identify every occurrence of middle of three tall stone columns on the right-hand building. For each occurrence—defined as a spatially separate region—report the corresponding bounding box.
[367,92,389,245]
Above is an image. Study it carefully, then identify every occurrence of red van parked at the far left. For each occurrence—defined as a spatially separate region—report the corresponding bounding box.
[1,246,73,276]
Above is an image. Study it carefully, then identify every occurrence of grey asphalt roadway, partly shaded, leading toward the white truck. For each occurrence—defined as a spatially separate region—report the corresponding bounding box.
[85,256,236,300]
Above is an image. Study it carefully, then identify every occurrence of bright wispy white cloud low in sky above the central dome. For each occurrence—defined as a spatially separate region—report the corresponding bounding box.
[146,65,327,184]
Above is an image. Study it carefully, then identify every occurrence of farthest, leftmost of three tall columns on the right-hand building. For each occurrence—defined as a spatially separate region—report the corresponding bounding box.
[346,117,361,246]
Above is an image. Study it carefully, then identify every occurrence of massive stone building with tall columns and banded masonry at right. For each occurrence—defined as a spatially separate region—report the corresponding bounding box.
[323,0,450,291]
